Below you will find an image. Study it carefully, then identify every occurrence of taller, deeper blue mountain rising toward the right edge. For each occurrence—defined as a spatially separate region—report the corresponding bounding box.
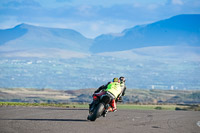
[90,14,200,53]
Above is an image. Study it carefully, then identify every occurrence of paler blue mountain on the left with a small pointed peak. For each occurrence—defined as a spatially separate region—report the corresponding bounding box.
[0,24,92,57]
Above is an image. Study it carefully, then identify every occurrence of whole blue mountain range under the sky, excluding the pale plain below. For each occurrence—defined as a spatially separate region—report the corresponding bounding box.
[0,14,200,57]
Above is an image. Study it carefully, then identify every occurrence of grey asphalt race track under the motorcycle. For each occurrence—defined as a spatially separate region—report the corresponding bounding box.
[0,107,200,133]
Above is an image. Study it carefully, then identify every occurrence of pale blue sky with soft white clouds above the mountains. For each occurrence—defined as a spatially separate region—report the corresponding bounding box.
[0,0,200,38]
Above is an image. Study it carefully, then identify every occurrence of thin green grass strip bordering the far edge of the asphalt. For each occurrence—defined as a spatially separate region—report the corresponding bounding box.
[0,102,200,111]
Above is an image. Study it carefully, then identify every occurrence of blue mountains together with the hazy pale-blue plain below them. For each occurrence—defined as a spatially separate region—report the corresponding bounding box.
[0,14,200,89]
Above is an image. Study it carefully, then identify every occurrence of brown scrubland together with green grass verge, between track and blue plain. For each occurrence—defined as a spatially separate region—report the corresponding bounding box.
[0,88,200,111]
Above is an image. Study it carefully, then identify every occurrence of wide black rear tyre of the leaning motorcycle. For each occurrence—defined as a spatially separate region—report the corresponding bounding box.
[87,103,104,121]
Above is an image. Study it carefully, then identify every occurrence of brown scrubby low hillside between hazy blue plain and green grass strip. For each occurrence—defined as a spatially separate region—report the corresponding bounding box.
[0,88,200,104]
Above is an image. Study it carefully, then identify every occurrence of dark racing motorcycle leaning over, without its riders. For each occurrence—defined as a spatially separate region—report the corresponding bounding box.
[87,91,115,121]
